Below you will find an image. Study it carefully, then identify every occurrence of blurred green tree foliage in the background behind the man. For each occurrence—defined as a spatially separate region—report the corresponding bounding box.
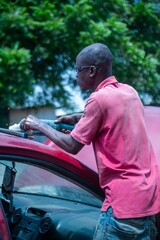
[0,0,160,110]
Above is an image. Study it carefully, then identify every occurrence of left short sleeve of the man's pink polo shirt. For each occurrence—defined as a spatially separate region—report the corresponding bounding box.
[71,95,103,145]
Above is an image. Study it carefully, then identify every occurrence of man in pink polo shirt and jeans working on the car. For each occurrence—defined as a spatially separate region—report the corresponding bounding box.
[24,43,160,240]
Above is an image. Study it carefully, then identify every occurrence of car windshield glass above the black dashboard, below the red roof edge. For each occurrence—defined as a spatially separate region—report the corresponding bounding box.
[0,161,101,207]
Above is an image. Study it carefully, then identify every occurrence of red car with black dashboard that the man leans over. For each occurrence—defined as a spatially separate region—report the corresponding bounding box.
[0,107,160,240]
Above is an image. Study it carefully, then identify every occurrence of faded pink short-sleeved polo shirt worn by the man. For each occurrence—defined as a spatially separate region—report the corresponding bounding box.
[71,76,160,218]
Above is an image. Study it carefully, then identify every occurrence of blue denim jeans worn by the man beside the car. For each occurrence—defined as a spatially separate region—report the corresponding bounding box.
[93,207,157,240]
